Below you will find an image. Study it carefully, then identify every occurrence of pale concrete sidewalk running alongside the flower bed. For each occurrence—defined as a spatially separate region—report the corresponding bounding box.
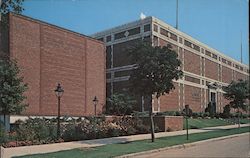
[0,124,250,158]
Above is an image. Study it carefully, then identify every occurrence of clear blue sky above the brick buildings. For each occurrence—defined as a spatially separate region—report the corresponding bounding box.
[23,0,249,64]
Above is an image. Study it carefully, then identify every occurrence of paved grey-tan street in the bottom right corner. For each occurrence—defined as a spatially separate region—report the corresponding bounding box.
[136,134,250,158]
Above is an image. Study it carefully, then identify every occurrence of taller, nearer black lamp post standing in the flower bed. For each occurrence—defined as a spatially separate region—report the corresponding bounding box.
[55,83,64,138]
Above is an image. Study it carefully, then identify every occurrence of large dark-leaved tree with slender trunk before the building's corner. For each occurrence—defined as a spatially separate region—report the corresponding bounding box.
[129,41,182,142]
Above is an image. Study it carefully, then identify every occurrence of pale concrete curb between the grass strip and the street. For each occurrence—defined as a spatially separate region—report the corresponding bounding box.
[116,132,249,158]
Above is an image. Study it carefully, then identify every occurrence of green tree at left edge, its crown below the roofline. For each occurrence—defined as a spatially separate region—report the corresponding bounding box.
[0,59,28,128]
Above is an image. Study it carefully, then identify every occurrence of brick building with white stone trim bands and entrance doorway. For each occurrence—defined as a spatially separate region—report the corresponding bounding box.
[92,17,249,112]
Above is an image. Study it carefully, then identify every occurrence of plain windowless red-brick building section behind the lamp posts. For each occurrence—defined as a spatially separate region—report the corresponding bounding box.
[0,14,106,116]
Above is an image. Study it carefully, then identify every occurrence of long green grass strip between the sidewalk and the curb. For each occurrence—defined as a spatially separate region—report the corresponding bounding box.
[16,127,250,158]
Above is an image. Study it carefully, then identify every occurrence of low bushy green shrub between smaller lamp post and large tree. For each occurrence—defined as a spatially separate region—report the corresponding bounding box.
[106,93,136,115]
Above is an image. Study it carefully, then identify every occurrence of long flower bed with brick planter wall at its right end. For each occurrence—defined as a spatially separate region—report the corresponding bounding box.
[0,116,183,147]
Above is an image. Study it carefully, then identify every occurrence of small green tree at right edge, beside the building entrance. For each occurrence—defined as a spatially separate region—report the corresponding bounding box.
[223,80,249,125]
